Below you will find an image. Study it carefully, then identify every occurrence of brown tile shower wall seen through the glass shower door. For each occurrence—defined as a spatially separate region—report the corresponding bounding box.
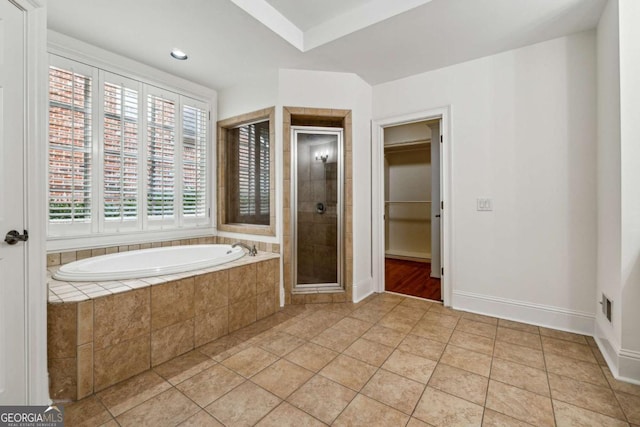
[297,143,338,284]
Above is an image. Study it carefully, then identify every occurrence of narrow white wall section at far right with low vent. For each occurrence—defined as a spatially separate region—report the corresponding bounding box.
[596,1,622,359]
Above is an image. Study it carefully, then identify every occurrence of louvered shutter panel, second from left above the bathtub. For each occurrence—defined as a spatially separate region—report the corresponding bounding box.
[103,75,140,223]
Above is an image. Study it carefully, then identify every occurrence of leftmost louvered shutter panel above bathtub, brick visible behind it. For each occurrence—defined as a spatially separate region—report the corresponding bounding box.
[48,64,93,229]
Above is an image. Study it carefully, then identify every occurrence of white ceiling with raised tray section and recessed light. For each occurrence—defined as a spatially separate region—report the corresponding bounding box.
[48,0,606,90]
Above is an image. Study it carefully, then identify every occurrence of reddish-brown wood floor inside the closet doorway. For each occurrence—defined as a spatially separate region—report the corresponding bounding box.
[384,258,442,301]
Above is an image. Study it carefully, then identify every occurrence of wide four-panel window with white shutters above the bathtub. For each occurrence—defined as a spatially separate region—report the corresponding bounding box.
[48,55,211,244]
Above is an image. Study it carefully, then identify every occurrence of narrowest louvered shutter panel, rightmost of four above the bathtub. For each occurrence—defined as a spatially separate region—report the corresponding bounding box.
[182,101,209,218]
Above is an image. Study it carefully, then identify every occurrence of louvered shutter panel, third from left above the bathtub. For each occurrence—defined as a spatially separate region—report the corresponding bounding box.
[147,94,177,219]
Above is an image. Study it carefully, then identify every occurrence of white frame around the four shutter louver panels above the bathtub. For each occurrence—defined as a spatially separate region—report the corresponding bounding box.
[46,52,215,251]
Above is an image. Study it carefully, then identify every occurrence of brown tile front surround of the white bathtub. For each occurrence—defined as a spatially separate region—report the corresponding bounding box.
[47,253,280,400]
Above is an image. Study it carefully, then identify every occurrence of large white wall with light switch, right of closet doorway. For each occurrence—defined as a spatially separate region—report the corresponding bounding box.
[373,31,596,333]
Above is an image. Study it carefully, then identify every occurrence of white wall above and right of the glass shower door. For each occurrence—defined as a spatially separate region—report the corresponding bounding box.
[277,69,373,301]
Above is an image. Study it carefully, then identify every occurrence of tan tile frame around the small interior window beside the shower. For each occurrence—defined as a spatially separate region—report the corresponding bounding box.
[216,107,276,236]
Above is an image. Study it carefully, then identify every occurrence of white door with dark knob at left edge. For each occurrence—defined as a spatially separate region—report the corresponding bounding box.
[0,0,27,405]
